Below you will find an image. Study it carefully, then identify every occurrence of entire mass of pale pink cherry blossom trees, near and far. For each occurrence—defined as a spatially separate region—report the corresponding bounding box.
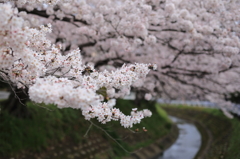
[0,0,240,123]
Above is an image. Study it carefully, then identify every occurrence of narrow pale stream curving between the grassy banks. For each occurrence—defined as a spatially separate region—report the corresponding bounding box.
[157,116,201,159]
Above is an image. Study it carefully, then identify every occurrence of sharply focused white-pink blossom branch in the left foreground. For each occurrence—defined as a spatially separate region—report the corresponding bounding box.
[0,4,156,127]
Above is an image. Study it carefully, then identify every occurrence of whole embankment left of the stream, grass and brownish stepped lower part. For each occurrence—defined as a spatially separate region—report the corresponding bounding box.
[0,100,172,159]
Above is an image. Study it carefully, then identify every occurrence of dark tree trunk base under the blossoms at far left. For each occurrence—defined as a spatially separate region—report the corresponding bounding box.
[3,88,30,118]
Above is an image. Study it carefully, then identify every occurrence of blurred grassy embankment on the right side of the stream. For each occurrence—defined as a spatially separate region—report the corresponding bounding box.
[159,106,240,159]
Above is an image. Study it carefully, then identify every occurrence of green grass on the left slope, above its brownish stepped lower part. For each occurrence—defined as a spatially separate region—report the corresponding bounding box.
[0,100,172,157]
